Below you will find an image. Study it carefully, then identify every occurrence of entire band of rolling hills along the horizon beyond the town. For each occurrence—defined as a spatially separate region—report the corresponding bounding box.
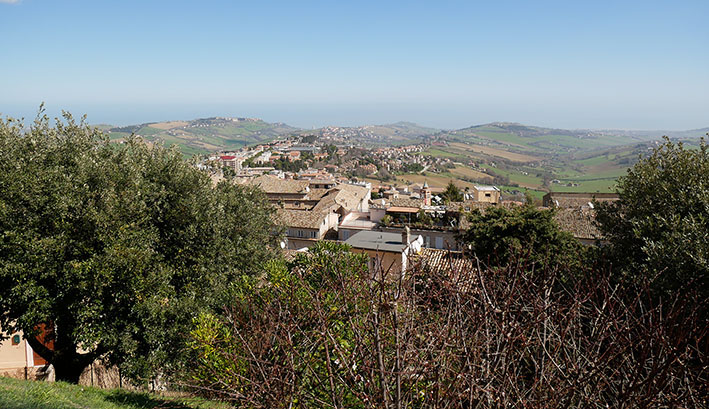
[99,117,709,198]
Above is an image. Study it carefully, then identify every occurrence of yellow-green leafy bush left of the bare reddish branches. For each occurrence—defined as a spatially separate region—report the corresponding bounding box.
[186,242,372,407]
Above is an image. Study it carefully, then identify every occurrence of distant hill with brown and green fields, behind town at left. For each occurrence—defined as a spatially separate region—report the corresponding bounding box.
[108,117,298,155]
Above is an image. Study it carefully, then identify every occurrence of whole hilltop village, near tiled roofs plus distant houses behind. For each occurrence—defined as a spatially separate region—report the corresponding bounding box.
[198,132,616,269]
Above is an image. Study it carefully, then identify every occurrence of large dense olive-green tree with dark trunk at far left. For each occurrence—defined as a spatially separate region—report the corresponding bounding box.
[0,114,277,382]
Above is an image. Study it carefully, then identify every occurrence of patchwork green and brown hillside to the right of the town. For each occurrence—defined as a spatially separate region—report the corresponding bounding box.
[401,122,706,195]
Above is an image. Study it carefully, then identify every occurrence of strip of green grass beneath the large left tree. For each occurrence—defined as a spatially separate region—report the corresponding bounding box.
[0,377,229,409]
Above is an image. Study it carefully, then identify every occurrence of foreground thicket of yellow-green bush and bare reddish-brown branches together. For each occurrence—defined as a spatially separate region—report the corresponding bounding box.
[185,243,708,409]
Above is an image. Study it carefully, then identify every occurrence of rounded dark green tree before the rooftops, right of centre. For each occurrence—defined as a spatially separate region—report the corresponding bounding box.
[460,203,585,266]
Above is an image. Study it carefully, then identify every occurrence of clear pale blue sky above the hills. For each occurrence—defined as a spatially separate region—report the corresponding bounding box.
[0,0,709,129]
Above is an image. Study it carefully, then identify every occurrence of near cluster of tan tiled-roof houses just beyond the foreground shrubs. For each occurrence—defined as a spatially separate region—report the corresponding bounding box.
[245,175,617,273]
